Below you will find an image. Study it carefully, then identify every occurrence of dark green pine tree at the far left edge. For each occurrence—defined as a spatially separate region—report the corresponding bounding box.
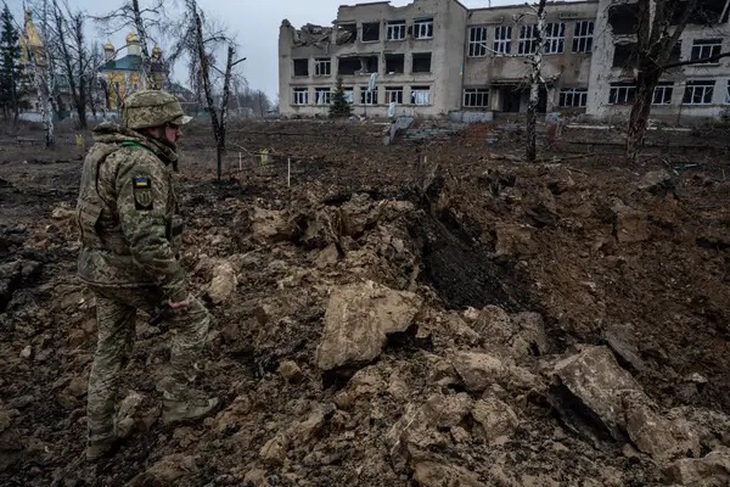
[0,4,24,120]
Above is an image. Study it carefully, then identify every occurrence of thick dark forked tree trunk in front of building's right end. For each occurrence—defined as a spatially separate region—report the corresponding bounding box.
[626,0,730,162]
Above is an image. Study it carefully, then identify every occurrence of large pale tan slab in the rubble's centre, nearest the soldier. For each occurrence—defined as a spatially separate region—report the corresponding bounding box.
[316,281,422,371]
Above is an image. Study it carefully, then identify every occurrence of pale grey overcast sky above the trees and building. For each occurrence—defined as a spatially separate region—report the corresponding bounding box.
[6,0,524,101]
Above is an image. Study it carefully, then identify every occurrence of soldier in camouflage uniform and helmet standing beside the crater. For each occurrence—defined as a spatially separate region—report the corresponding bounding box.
[76,90,218,460]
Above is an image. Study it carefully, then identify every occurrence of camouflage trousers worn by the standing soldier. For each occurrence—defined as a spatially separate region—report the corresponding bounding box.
[87,286,210,441]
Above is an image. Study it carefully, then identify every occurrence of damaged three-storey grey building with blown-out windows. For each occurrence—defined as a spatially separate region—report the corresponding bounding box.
[279,0,730,121]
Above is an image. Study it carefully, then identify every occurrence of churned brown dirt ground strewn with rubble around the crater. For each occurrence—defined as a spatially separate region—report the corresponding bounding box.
[0,121,730,487]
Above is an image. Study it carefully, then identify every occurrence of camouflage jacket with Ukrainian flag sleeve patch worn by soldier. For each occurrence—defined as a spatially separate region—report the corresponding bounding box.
[76,122,188,301]
